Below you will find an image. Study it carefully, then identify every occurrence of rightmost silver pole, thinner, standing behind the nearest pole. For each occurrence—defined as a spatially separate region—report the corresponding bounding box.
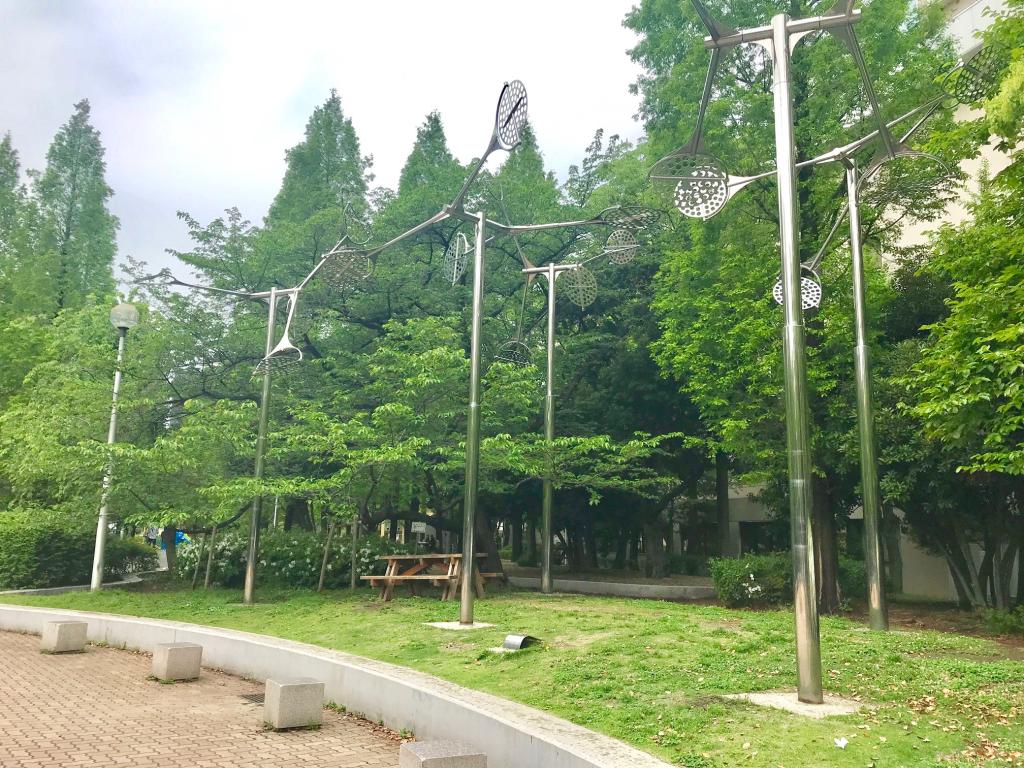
[846,161,889,632]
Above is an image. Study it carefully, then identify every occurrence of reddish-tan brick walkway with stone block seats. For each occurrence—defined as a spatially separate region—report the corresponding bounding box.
[0,632,398,768]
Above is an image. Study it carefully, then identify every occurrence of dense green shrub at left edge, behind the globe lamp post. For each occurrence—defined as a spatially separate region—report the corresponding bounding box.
[0,509,156,589]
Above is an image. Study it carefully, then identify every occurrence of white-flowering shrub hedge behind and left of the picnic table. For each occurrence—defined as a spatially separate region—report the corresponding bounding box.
[175,529,408,588]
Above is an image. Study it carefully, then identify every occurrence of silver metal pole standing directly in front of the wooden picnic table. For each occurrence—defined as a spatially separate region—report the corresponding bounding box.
[459,212,487,625]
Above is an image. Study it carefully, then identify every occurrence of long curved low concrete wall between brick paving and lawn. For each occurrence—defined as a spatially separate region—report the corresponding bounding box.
[0,605,670,768]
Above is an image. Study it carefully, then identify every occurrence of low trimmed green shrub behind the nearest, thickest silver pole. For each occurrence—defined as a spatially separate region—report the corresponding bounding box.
[711,552,867,607]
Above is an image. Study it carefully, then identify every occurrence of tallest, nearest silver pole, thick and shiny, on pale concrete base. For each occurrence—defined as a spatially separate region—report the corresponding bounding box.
[771,13,824,703]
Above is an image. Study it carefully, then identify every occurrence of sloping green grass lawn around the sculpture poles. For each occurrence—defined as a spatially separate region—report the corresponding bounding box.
[0,589,1024,768]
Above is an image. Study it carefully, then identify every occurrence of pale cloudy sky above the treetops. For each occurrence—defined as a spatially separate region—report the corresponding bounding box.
[0,0,640,276]
